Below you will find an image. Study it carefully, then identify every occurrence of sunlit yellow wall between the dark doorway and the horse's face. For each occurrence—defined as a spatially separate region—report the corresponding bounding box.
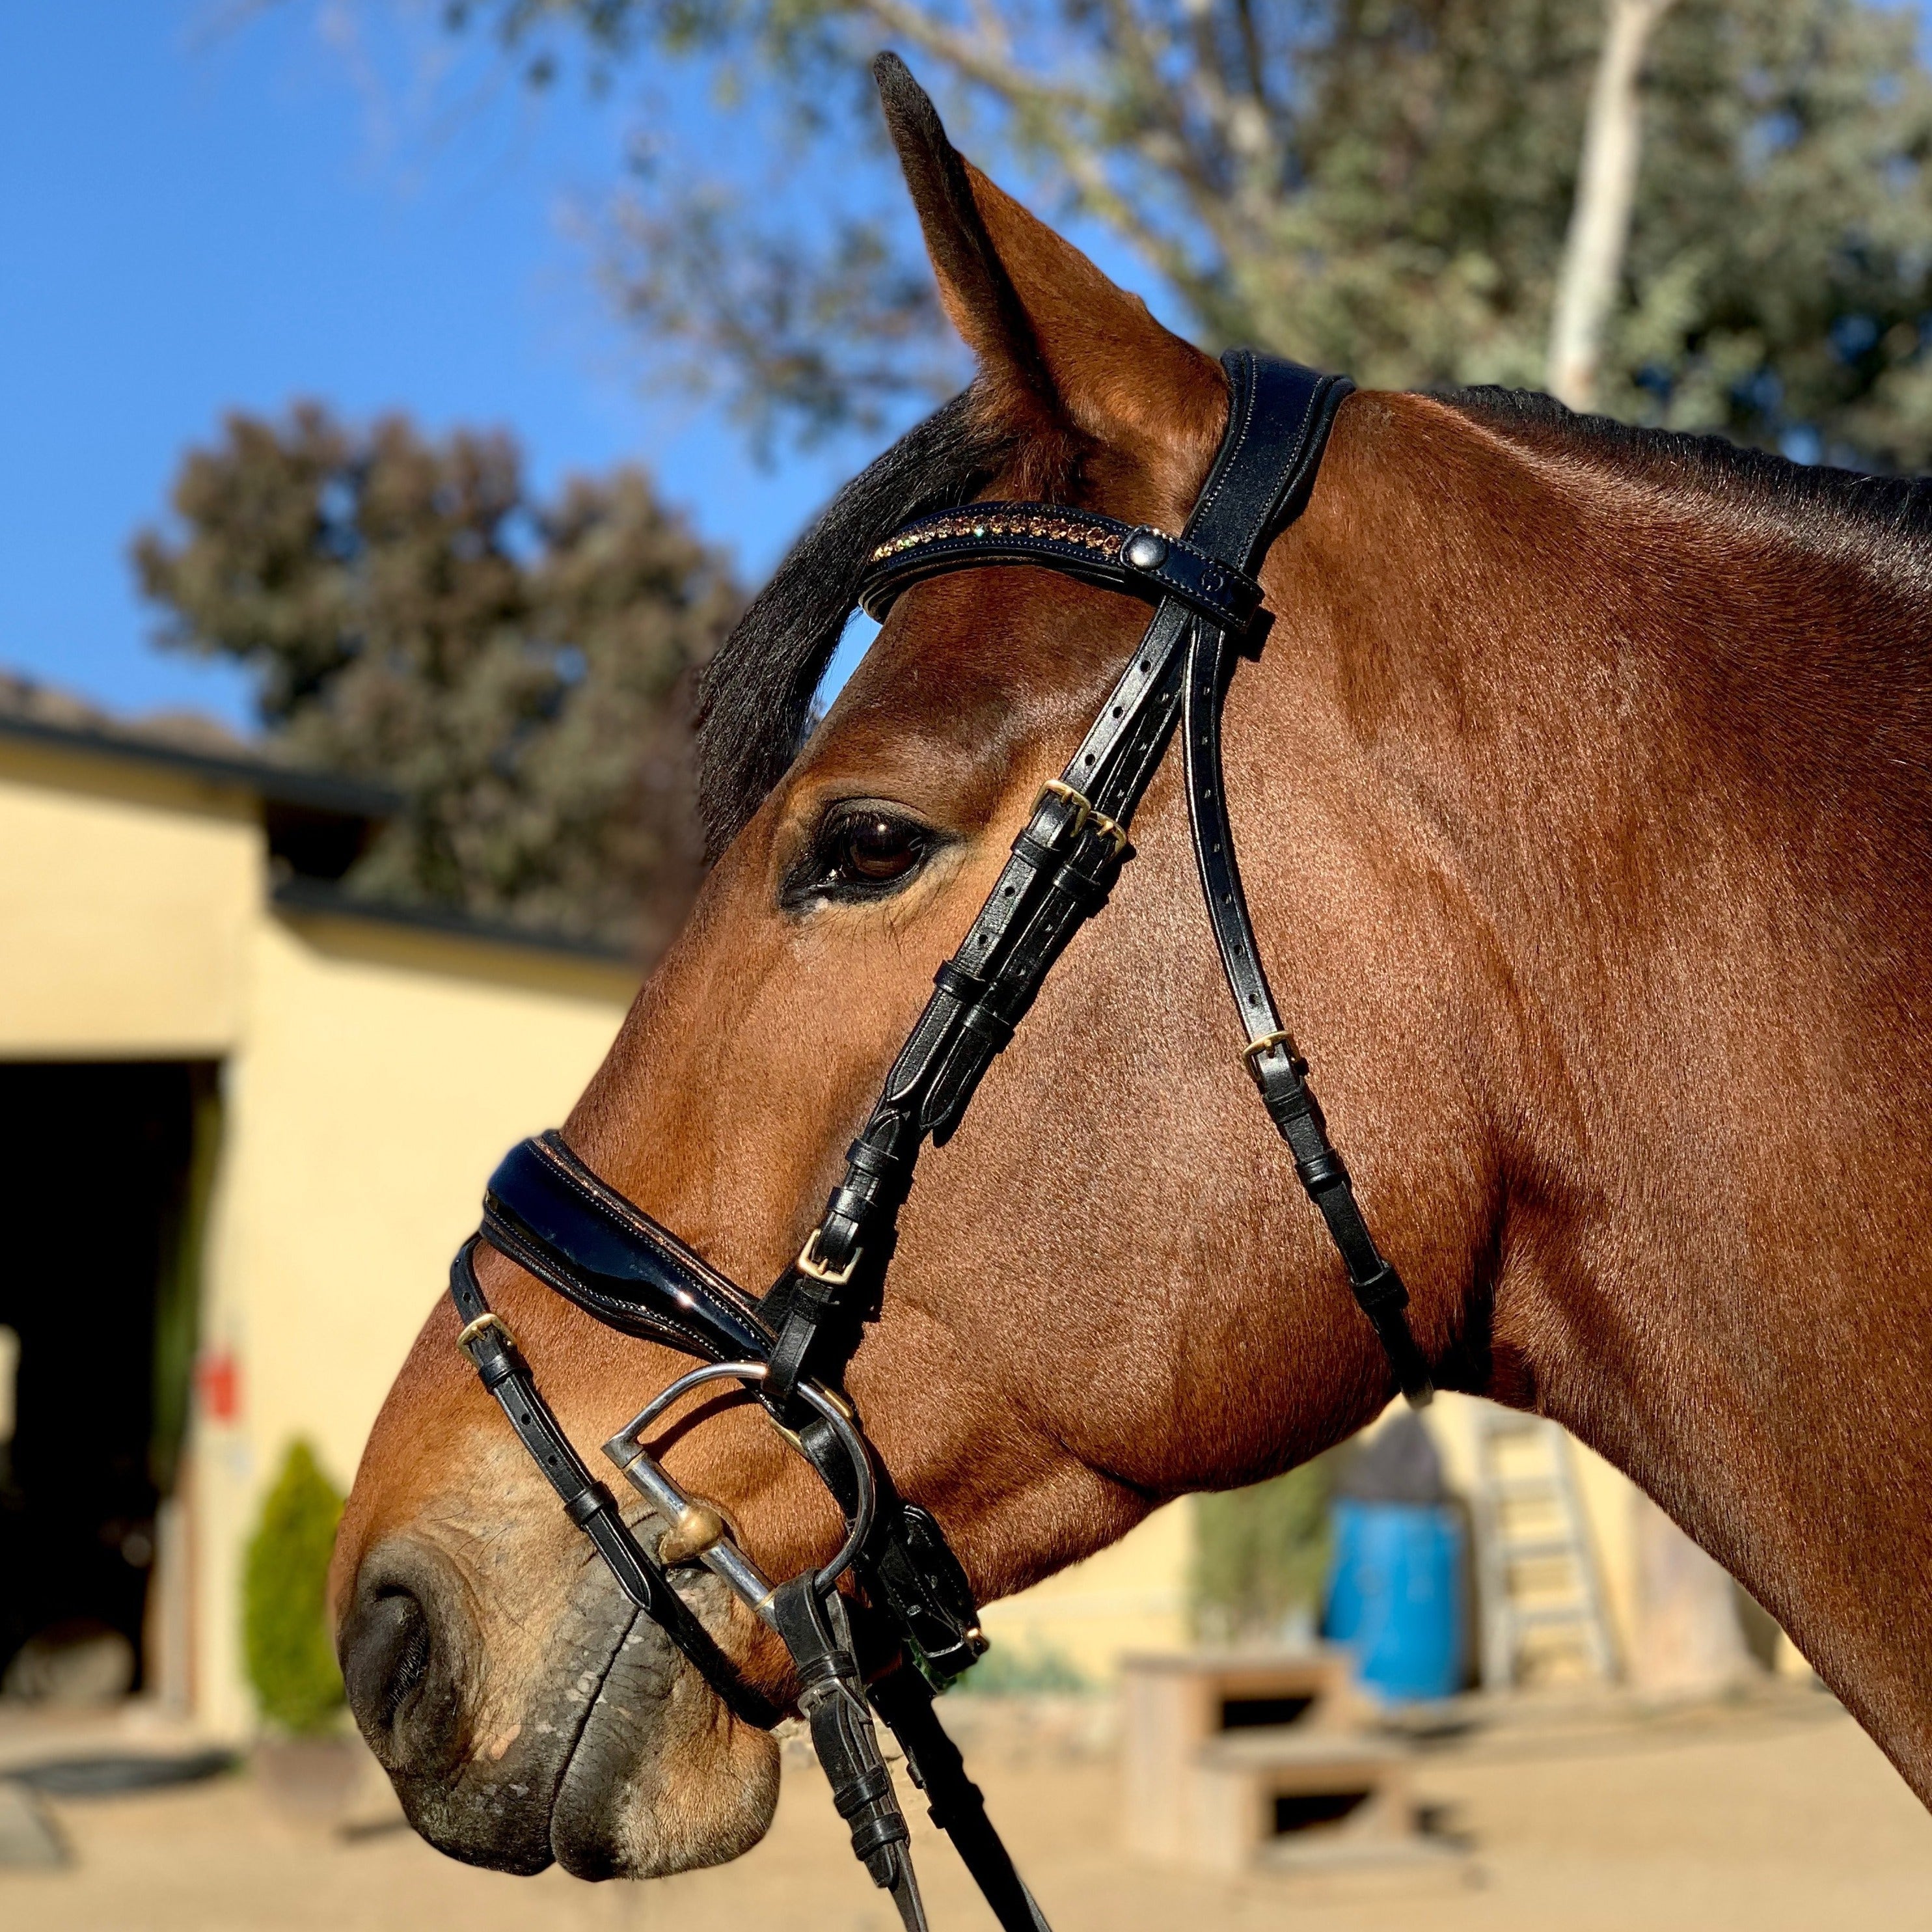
[191,914,636,1731]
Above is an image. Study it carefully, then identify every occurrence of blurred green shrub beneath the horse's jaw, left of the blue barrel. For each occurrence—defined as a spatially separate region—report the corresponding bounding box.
[1190,1457,1333,1642]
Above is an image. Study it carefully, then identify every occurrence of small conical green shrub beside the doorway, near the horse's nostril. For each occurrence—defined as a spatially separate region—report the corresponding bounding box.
[241,1441,342,1737]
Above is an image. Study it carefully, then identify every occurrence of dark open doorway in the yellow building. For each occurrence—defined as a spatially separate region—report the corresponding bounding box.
[0,1061,218,1689]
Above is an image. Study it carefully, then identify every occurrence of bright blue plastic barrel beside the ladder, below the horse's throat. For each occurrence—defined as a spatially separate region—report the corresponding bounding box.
[1326,1499,1463,1702]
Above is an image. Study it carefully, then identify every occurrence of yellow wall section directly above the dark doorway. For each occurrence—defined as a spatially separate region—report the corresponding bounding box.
[0,744,263,1059]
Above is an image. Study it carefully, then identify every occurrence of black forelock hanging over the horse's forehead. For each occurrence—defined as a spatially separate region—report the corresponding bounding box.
[698,388,1011,858]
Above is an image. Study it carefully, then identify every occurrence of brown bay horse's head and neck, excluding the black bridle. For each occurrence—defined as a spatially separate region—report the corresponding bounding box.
[333,56,1932,1878]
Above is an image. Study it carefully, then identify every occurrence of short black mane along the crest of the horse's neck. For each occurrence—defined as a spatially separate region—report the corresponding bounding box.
[1437,387,1932,547]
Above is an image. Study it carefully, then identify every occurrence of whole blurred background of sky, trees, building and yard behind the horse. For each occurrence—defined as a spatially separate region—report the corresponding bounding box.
[0,0,1932,1928]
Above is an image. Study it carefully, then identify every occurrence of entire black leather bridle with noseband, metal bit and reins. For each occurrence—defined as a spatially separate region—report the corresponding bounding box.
[450,349,1430,1932]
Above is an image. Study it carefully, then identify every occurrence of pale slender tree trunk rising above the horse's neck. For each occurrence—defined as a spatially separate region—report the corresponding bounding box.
[1549,0,1671,409]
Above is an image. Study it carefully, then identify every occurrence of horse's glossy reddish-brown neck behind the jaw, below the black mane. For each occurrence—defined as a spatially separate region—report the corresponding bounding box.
[1313,392,1932,1799]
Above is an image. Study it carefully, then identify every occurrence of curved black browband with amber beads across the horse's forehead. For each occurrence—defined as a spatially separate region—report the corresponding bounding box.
[858,502,1262,632]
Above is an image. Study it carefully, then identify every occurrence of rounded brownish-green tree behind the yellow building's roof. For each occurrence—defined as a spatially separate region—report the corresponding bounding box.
[133,404,738,951]
